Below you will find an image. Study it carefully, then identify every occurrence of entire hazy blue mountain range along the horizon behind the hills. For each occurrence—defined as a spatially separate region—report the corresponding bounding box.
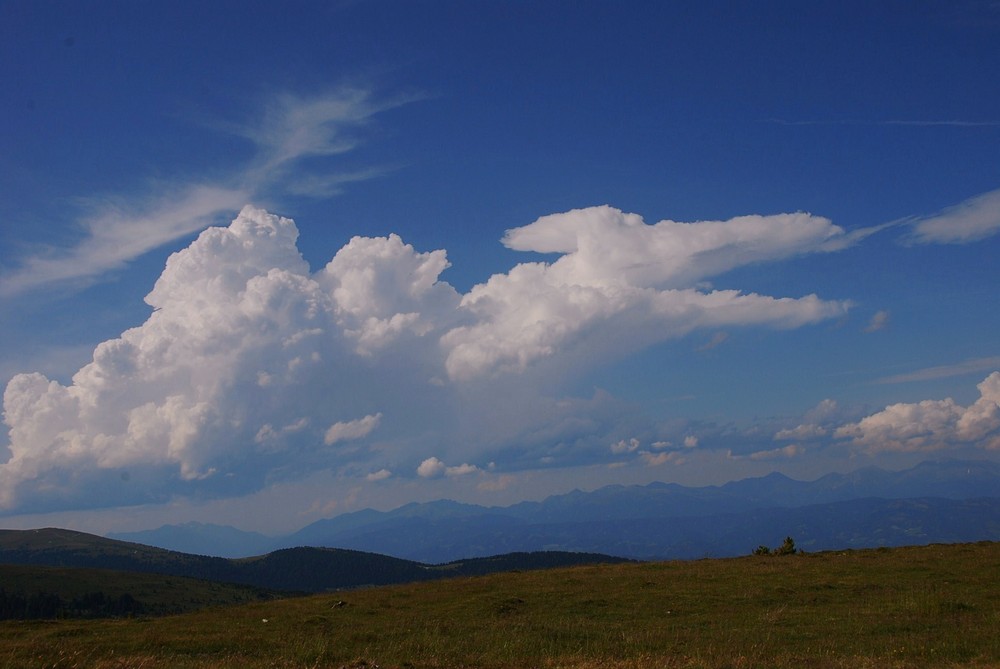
[109,460,1000,564]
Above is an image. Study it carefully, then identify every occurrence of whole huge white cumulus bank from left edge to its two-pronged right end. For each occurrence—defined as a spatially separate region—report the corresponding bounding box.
[0,204,863,511]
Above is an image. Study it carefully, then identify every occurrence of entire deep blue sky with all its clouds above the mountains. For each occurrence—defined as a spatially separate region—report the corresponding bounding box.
[0,0,1000,532]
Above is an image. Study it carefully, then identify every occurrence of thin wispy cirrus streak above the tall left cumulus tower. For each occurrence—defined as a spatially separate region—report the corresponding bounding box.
[0,88,413,297]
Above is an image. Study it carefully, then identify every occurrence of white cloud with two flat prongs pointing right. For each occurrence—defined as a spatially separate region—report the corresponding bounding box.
[442,206,850,379]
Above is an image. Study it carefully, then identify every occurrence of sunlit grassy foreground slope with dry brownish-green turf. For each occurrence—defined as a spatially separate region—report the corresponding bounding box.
[0,543,1000,669]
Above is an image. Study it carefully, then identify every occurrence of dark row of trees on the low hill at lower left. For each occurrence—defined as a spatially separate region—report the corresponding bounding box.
[0,588,145,620]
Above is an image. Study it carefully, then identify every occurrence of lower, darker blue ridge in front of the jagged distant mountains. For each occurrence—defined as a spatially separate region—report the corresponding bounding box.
[278,497,1000,562]
